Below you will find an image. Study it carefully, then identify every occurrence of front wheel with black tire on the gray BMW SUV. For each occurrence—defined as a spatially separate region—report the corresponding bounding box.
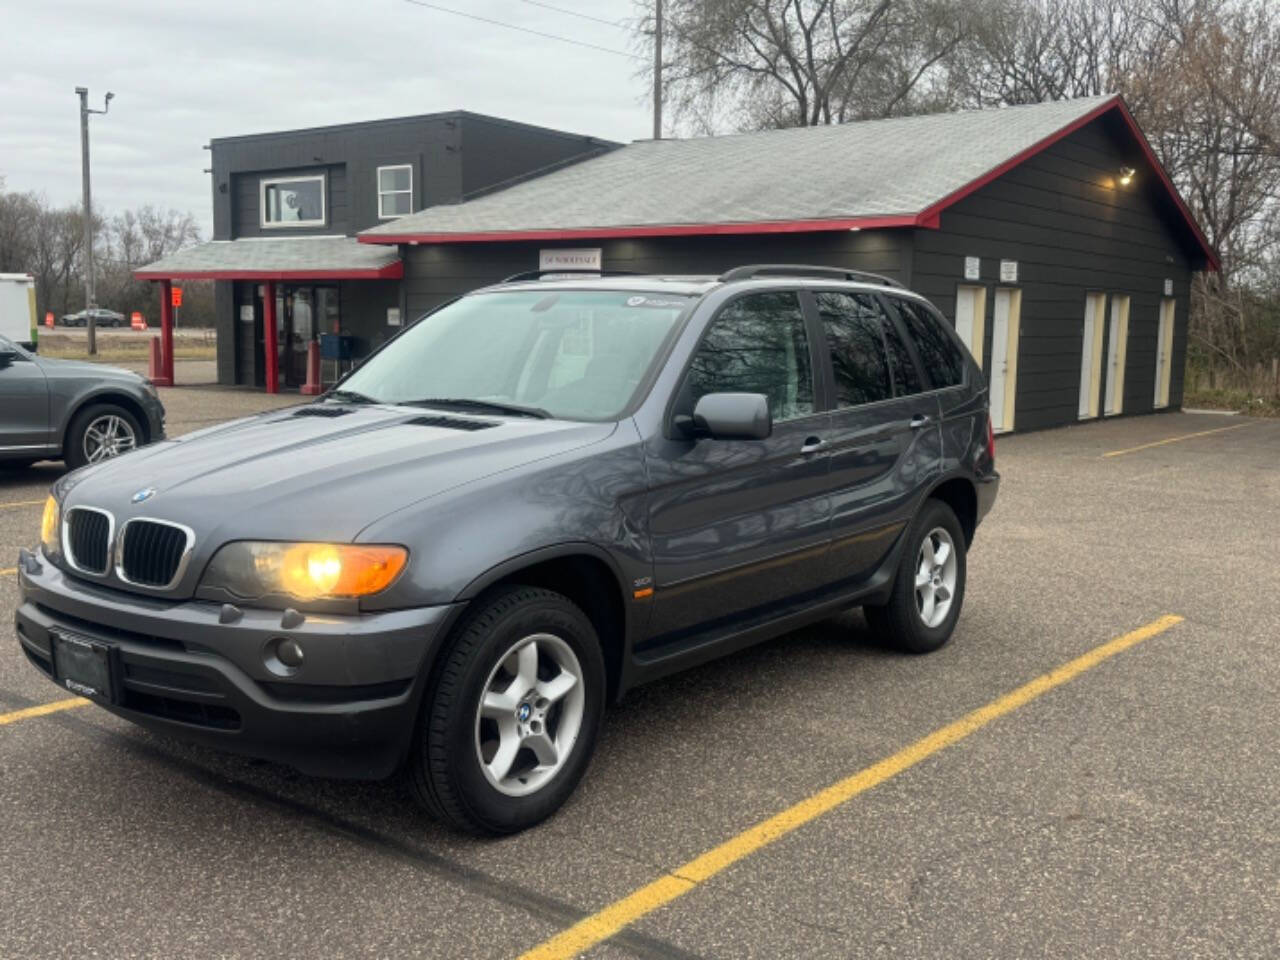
[408,586,605,835]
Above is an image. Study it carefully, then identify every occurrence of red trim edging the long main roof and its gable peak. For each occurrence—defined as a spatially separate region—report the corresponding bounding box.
[357,95,1219,270]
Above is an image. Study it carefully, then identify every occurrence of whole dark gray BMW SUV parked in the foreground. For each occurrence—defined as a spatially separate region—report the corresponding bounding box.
[17,266,998,833]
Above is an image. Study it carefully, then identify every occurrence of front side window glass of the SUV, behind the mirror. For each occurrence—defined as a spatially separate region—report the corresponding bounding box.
[686,293,813,421]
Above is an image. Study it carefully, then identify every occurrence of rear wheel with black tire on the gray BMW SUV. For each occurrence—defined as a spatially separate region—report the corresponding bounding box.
[863,499,966,654]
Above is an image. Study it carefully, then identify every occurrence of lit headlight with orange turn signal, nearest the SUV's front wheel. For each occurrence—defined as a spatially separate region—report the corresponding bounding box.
[200,540,408,600]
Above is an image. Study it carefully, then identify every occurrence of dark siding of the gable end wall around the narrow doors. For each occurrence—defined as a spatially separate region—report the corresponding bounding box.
[909,118,1197,430]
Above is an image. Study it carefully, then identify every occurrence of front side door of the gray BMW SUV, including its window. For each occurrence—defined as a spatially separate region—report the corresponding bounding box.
[637,292,831,653]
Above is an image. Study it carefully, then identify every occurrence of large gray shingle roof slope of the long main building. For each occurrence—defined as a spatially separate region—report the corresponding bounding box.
[361,97,1114,242]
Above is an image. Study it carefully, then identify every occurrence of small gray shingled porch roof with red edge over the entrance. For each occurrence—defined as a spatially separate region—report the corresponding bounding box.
[134,237,399,279]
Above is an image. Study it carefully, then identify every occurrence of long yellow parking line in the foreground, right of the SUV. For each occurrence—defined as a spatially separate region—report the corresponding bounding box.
[520,616,1183,960]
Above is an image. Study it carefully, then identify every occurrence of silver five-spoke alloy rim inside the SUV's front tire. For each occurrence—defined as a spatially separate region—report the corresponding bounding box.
[476,634,586,796]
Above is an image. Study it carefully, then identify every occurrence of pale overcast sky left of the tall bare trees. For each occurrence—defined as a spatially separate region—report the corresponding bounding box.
[0,0,652,237]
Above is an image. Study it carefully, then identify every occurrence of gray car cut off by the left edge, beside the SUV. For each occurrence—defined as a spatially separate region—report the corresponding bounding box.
[0,337,164,467]
